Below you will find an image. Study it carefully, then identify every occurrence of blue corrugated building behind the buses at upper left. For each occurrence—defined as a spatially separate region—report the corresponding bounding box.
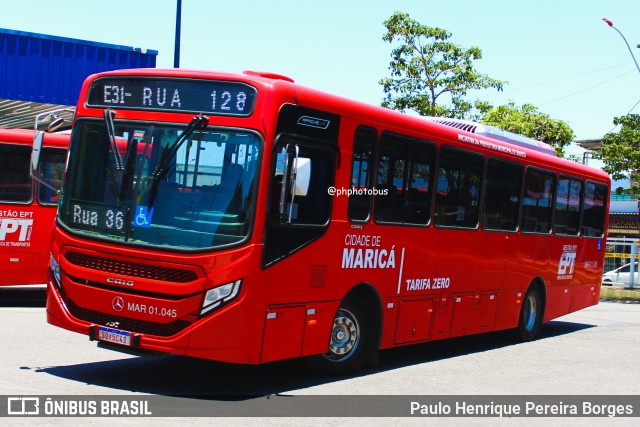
[0,28,158,129]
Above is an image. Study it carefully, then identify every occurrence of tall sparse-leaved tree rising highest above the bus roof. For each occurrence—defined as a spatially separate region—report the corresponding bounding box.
[380,12,506,118]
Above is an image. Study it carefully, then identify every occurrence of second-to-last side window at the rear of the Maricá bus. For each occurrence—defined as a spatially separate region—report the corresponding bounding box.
[553,176,582,236]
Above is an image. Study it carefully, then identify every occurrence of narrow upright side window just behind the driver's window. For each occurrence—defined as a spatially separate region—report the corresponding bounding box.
[349,127,377,221]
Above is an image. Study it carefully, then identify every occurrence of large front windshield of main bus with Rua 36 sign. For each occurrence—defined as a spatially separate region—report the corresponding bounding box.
[58,120,260,249]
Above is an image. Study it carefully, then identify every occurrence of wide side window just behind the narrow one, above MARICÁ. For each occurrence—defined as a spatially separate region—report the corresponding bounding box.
[375,133,436,225]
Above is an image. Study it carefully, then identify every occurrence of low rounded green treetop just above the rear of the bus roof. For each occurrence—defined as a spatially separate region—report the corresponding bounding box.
[480,102,575,157]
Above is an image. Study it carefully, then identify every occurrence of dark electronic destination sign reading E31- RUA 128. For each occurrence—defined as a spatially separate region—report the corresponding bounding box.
[87,77,257,116]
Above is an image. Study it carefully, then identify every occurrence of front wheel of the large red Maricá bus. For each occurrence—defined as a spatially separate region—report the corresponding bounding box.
[307,296,374,376]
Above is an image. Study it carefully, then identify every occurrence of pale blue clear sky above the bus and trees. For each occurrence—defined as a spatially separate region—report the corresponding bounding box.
[0,0,640,159]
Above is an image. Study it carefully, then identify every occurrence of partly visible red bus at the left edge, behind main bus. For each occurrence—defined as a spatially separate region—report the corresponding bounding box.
[0,129,70,286]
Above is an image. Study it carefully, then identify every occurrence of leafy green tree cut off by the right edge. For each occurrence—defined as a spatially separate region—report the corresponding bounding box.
[594,114,640,193]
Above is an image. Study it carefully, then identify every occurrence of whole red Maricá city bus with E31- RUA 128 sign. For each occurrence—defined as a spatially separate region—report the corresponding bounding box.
[38,69,610,373]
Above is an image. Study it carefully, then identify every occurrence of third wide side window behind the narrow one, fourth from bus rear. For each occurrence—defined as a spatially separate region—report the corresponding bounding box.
[482,159,524,231]
